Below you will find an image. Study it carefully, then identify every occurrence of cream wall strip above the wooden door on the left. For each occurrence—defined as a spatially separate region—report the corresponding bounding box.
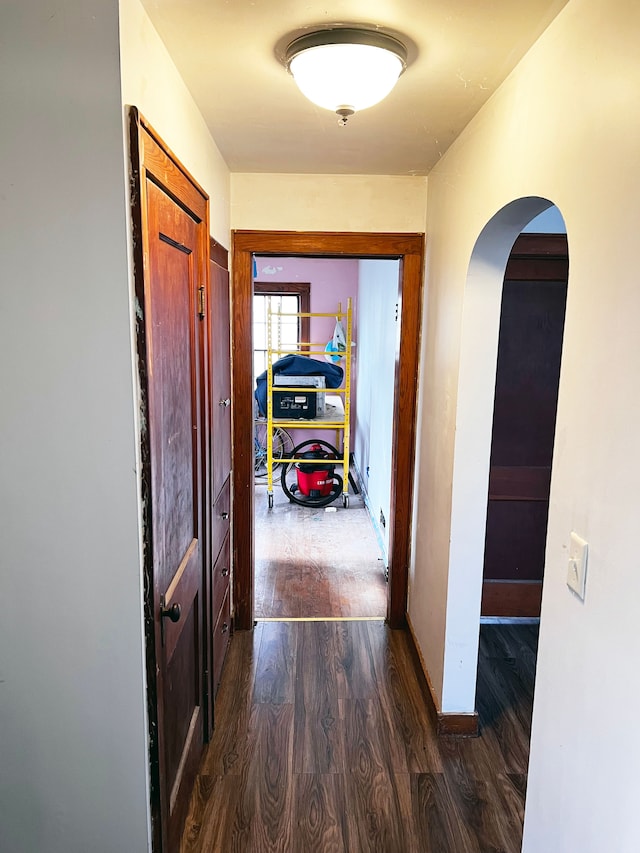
[119,0,230,243]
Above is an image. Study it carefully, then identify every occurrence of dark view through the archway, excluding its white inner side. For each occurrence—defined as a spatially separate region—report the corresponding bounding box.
[476,208,569,788]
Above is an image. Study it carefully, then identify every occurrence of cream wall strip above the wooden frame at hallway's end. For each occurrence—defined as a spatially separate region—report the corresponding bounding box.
[231,173,427,232]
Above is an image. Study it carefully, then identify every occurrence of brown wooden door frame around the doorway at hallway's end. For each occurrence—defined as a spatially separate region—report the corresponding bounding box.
[232,231,425,630]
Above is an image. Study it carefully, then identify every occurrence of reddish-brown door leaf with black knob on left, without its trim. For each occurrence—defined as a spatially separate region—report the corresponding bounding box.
[146,181,204,850]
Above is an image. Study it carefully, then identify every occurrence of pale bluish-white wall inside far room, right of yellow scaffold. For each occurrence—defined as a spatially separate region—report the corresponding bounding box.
[353,260,400,564]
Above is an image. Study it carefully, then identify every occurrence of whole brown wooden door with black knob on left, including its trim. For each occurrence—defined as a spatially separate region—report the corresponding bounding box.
[132,110,208,853]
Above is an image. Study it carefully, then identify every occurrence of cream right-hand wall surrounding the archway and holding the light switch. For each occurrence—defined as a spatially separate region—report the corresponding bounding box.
[409,0,640,853]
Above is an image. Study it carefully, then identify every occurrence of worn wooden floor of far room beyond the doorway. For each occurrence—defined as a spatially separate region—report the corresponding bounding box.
[254,482,387,619]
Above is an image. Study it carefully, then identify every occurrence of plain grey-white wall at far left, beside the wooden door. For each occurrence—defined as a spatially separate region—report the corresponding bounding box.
[0,0,149,853]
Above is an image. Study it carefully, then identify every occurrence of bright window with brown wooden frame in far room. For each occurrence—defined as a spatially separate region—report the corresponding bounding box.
[253,282,311,380]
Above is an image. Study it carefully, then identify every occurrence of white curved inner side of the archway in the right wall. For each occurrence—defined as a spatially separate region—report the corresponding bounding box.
[442,196,568,714]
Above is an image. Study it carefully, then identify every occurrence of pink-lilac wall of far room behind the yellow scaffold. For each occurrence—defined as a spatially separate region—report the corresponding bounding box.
[255,257,358,446]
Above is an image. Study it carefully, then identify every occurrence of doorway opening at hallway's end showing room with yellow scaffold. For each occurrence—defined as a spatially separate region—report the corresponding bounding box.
[253,256,400,619]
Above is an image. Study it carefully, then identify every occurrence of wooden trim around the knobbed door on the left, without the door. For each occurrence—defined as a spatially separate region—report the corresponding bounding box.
[129,107,209,851]
